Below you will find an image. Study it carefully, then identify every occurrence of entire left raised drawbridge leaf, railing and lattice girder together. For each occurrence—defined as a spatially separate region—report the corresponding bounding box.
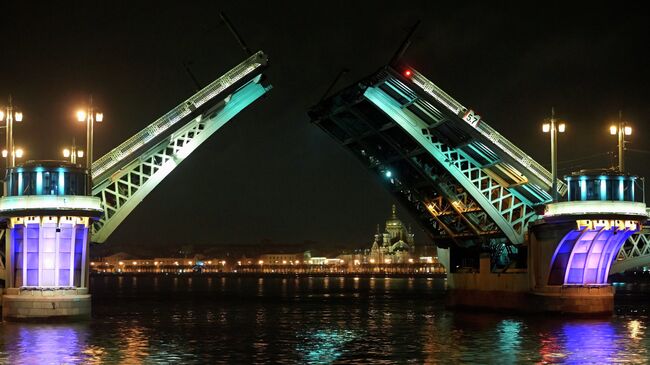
[92,52,271,242]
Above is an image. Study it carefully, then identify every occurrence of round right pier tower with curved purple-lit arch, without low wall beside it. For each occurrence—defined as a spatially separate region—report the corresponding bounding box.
[528,171,648,313]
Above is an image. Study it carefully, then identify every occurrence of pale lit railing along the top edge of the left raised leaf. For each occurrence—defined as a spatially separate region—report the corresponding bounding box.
[92,51,268,179]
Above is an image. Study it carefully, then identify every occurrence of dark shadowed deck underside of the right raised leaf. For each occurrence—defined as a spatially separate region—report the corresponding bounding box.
[316,90,504,246]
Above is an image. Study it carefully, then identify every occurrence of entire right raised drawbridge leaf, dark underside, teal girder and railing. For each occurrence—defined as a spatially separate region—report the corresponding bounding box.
[310,67,566,246]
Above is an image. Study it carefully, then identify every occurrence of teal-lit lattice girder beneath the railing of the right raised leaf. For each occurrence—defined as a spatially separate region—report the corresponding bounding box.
[364,86,537,244]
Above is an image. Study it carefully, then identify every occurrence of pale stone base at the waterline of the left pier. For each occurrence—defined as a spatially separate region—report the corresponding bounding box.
[2,288,91,322]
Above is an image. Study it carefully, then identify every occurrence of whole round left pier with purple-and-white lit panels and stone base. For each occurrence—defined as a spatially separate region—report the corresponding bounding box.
[0,161,102,320]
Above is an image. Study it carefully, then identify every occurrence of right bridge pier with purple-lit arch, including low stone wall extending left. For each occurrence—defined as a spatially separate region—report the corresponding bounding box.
[449,171,648,314]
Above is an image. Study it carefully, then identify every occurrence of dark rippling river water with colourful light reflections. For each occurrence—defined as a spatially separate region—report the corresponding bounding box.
[0,276,650,365]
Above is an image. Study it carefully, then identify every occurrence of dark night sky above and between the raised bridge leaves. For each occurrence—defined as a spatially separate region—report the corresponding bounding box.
[0,1,650,250]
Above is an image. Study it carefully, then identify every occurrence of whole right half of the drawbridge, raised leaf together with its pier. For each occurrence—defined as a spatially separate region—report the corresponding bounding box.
[309,62,650,314]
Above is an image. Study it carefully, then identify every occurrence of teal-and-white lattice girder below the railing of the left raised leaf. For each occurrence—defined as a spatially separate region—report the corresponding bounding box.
[92,76,270,242]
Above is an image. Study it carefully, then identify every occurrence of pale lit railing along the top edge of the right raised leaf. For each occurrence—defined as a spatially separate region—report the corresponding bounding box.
[410,69,567,194]
